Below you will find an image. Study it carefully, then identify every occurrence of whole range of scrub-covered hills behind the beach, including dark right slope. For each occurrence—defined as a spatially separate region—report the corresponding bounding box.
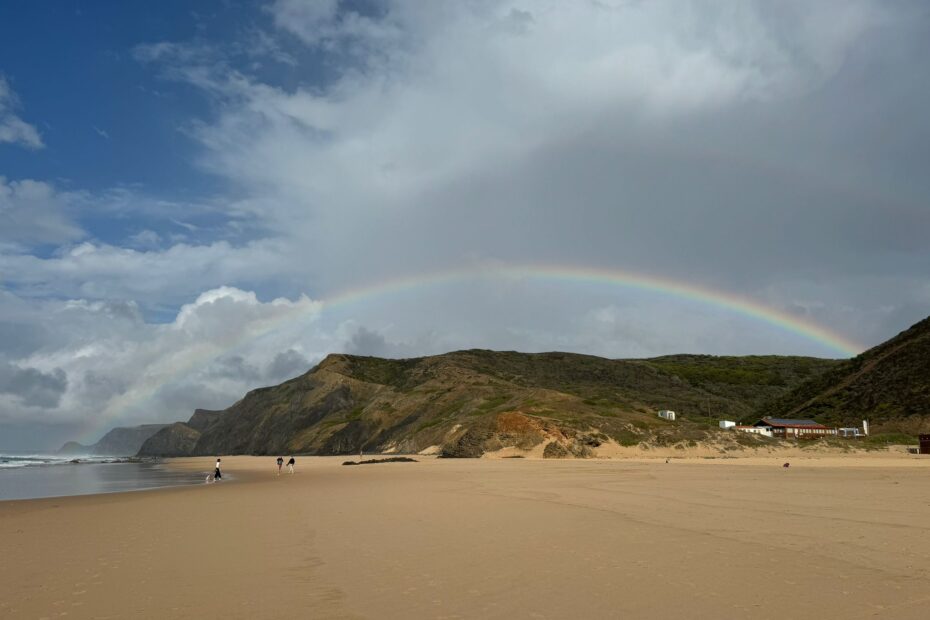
[136,312,930,457]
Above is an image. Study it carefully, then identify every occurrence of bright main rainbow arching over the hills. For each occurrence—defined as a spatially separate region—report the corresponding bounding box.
[83,265,865,438]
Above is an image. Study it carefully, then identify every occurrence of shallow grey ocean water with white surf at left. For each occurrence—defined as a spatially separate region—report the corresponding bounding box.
[0,454,207,501]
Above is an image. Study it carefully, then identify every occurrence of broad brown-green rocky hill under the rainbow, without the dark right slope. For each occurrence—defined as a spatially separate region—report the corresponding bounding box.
[136,351,835,456]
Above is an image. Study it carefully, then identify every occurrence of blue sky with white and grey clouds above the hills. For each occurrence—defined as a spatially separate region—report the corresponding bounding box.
[0,0,930,450]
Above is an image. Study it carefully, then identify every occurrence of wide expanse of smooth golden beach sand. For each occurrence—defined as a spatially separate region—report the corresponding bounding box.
[0,455,930,620]
